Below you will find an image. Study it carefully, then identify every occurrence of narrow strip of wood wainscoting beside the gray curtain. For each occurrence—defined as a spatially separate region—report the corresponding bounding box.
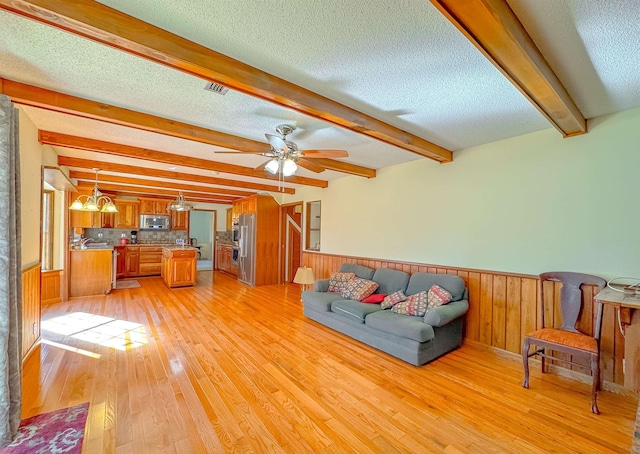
[22,263,40,358]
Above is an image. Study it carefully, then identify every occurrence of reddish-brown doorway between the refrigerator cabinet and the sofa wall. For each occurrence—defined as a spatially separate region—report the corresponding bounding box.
[280,202,302,283]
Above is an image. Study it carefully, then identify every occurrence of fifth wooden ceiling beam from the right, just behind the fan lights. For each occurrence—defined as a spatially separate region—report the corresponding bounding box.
[58,155,296,194]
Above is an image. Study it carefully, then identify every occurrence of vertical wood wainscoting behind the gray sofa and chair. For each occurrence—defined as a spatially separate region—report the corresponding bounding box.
[302,251,624,385]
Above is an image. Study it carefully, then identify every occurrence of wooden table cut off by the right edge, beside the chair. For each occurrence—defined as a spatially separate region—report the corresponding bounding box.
[595,287,640,391]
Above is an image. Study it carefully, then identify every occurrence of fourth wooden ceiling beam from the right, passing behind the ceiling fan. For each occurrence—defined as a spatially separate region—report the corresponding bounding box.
[38,131,328,188]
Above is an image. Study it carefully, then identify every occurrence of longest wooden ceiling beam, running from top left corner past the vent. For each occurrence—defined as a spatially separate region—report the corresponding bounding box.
[0,0,453,162]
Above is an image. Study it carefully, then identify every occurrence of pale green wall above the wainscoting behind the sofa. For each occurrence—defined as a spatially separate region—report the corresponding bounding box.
[285,109,640,277]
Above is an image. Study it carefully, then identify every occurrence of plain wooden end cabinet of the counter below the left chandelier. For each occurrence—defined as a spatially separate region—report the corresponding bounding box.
[69,249,114,297]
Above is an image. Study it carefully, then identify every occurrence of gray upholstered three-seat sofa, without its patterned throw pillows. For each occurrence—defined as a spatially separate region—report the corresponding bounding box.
[302,263,469,366]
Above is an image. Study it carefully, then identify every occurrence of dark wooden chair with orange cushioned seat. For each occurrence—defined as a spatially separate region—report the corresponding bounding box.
[522,271,606,415]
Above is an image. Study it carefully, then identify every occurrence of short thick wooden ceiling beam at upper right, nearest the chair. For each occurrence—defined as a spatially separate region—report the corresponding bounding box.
[431,0,587,137]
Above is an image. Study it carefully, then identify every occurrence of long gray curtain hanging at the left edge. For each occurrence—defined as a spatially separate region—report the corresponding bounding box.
[0,95,22,446]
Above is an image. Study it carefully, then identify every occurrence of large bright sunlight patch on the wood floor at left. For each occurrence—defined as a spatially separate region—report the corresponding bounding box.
[42,312,148,351]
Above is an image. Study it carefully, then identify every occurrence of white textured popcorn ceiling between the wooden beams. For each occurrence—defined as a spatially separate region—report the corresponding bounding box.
[0,0,640,197]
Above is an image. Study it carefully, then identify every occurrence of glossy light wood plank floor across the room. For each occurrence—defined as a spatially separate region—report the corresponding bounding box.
[24,272,637,454]
